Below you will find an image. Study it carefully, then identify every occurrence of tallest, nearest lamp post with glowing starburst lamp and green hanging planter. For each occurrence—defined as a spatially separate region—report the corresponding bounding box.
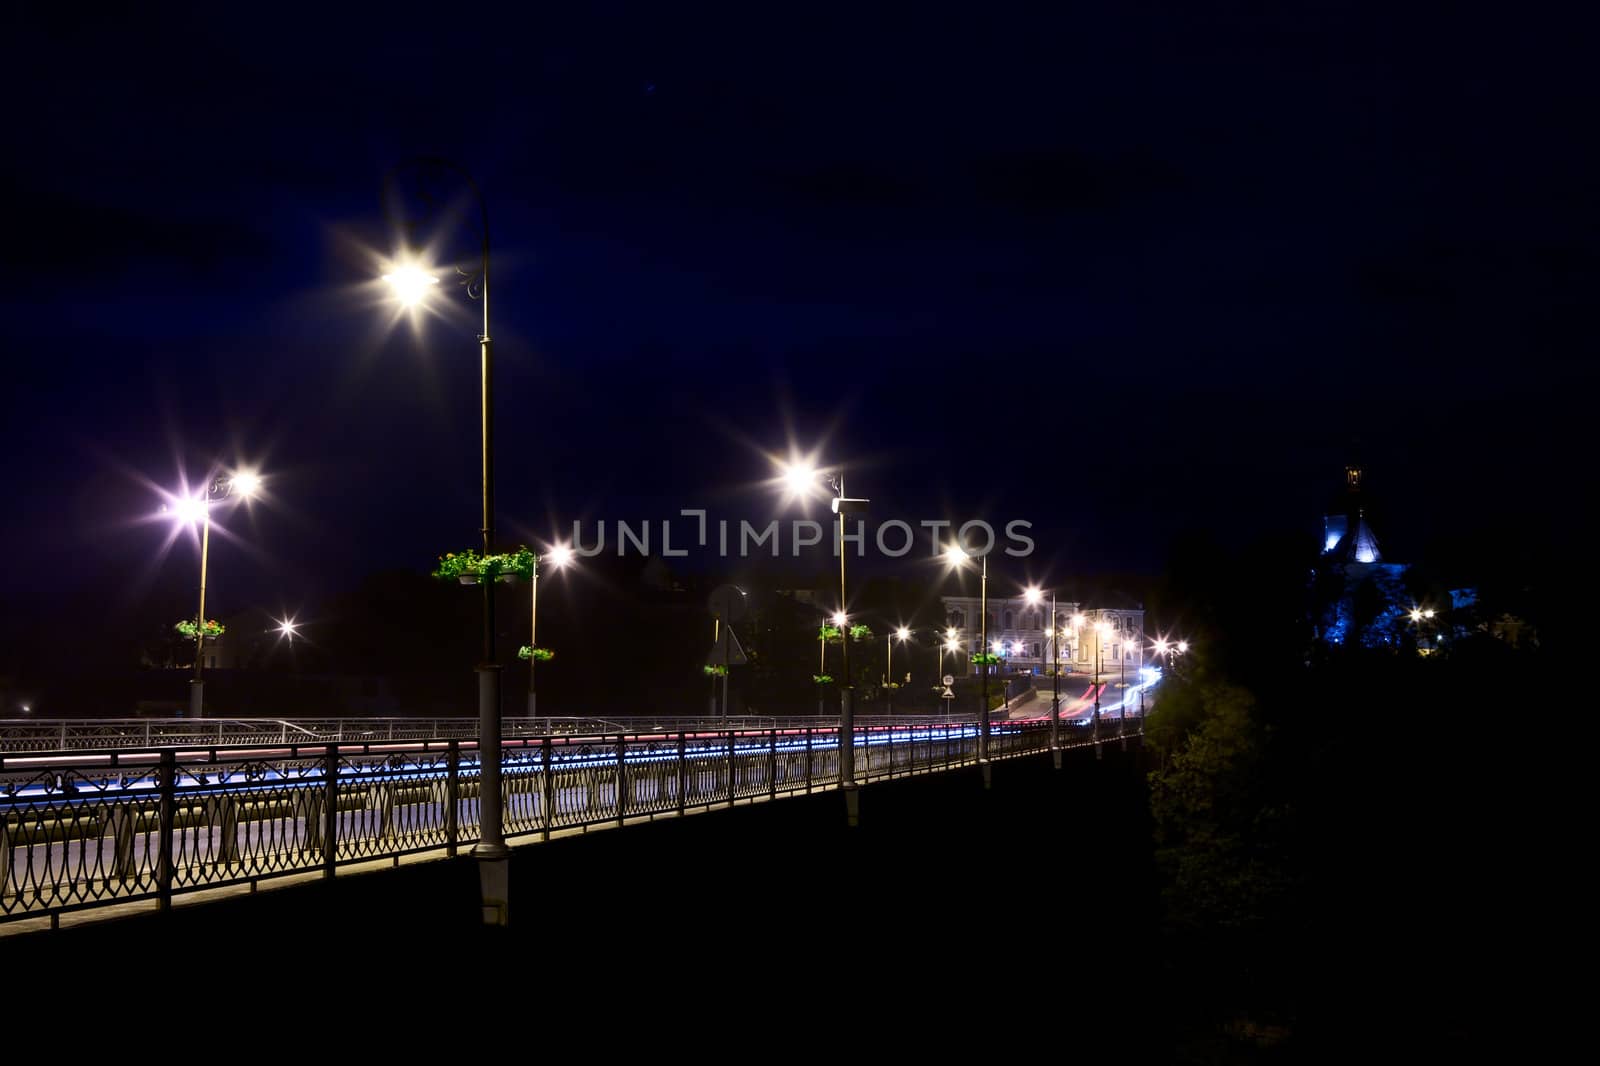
[384,157,510,925]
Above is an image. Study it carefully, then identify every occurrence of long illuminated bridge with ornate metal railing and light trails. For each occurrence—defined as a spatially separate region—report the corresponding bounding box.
[0,707,1142,928]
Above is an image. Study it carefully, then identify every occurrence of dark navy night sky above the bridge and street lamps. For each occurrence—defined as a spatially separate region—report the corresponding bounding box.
[0,3,1600,656]
